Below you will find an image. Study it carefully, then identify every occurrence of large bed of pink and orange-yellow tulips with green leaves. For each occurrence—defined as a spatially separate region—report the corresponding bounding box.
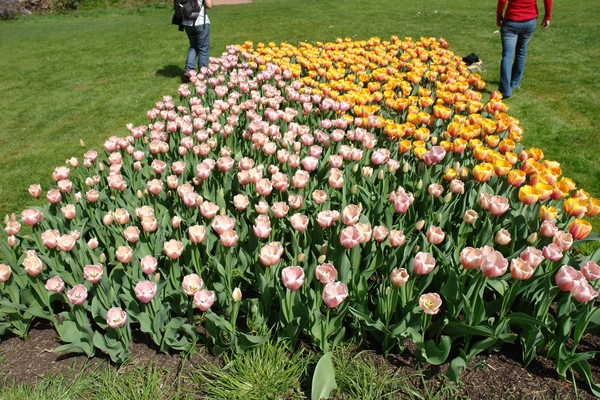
[0,37,600,393]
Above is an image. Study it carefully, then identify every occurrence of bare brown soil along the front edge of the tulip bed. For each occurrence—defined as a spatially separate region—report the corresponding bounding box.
[0,323,600,400]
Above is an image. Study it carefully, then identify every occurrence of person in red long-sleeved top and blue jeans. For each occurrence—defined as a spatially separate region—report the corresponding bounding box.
[496,0,552,99]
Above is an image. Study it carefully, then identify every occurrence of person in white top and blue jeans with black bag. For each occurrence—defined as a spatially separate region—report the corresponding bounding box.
[181,0,213,79]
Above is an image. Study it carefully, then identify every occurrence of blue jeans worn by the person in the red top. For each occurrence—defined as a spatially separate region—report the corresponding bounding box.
[498,18,537,97]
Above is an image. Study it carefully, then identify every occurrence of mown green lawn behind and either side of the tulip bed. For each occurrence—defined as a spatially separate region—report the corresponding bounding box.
[0,0,600,230]
